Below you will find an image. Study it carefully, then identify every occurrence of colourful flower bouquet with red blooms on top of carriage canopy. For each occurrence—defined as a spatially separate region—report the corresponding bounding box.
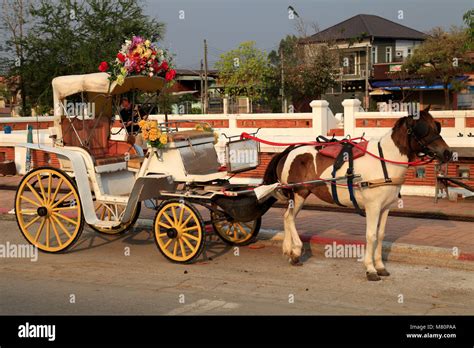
[99,36,176,85]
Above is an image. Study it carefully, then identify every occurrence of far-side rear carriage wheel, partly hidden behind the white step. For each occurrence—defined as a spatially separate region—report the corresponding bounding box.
[89,201,141,234]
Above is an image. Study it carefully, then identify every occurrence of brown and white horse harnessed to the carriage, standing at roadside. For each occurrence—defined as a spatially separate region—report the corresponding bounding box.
[264,107,452,280]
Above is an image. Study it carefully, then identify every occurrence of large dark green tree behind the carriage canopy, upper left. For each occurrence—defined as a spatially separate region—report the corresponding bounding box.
[7,0,164,108]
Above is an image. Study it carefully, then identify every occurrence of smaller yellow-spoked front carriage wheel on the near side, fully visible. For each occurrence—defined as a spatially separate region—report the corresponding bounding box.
[153,199,204,263]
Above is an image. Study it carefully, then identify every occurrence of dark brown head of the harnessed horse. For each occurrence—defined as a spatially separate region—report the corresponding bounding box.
[392,106,452,162]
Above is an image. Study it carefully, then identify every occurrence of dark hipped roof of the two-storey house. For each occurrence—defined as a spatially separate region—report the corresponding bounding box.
[306,14,427,42]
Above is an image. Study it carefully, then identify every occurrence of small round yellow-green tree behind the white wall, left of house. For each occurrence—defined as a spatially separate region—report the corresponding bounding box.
[215,41,271,100]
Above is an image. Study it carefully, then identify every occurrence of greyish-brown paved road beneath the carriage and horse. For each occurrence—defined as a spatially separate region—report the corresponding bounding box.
[0,220,474,314]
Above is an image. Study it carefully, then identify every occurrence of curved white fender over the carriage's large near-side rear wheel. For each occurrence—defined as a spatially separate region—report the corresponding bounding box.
[15,143,100,225]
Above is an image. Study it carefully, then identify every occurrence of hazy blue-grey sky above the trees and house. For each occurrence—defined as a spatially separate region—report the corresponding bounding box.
[143,0,474,69]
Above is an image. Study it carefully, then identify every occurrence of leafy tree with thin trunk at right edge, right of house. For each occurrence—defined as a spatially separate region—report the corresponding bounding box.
[402,28,470,110]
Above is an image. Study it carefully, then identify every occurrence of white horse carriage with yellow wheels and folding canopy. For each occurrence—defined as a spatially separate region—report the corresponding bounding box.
[15,73,275,262]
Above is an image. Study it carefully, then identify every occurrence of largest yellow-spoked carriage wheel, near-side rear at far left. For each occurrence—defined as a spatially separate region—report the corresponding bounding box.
[15,167,84,253]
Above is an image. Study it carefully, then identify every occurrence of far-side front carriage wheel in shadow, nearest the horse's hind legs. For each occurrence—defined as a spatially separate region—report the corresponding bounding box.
[211,212,262,245]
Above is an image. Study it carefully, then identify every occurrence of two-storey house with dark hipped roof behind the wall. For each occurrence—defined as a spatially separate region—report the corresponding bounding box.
[303,14,427,112]
